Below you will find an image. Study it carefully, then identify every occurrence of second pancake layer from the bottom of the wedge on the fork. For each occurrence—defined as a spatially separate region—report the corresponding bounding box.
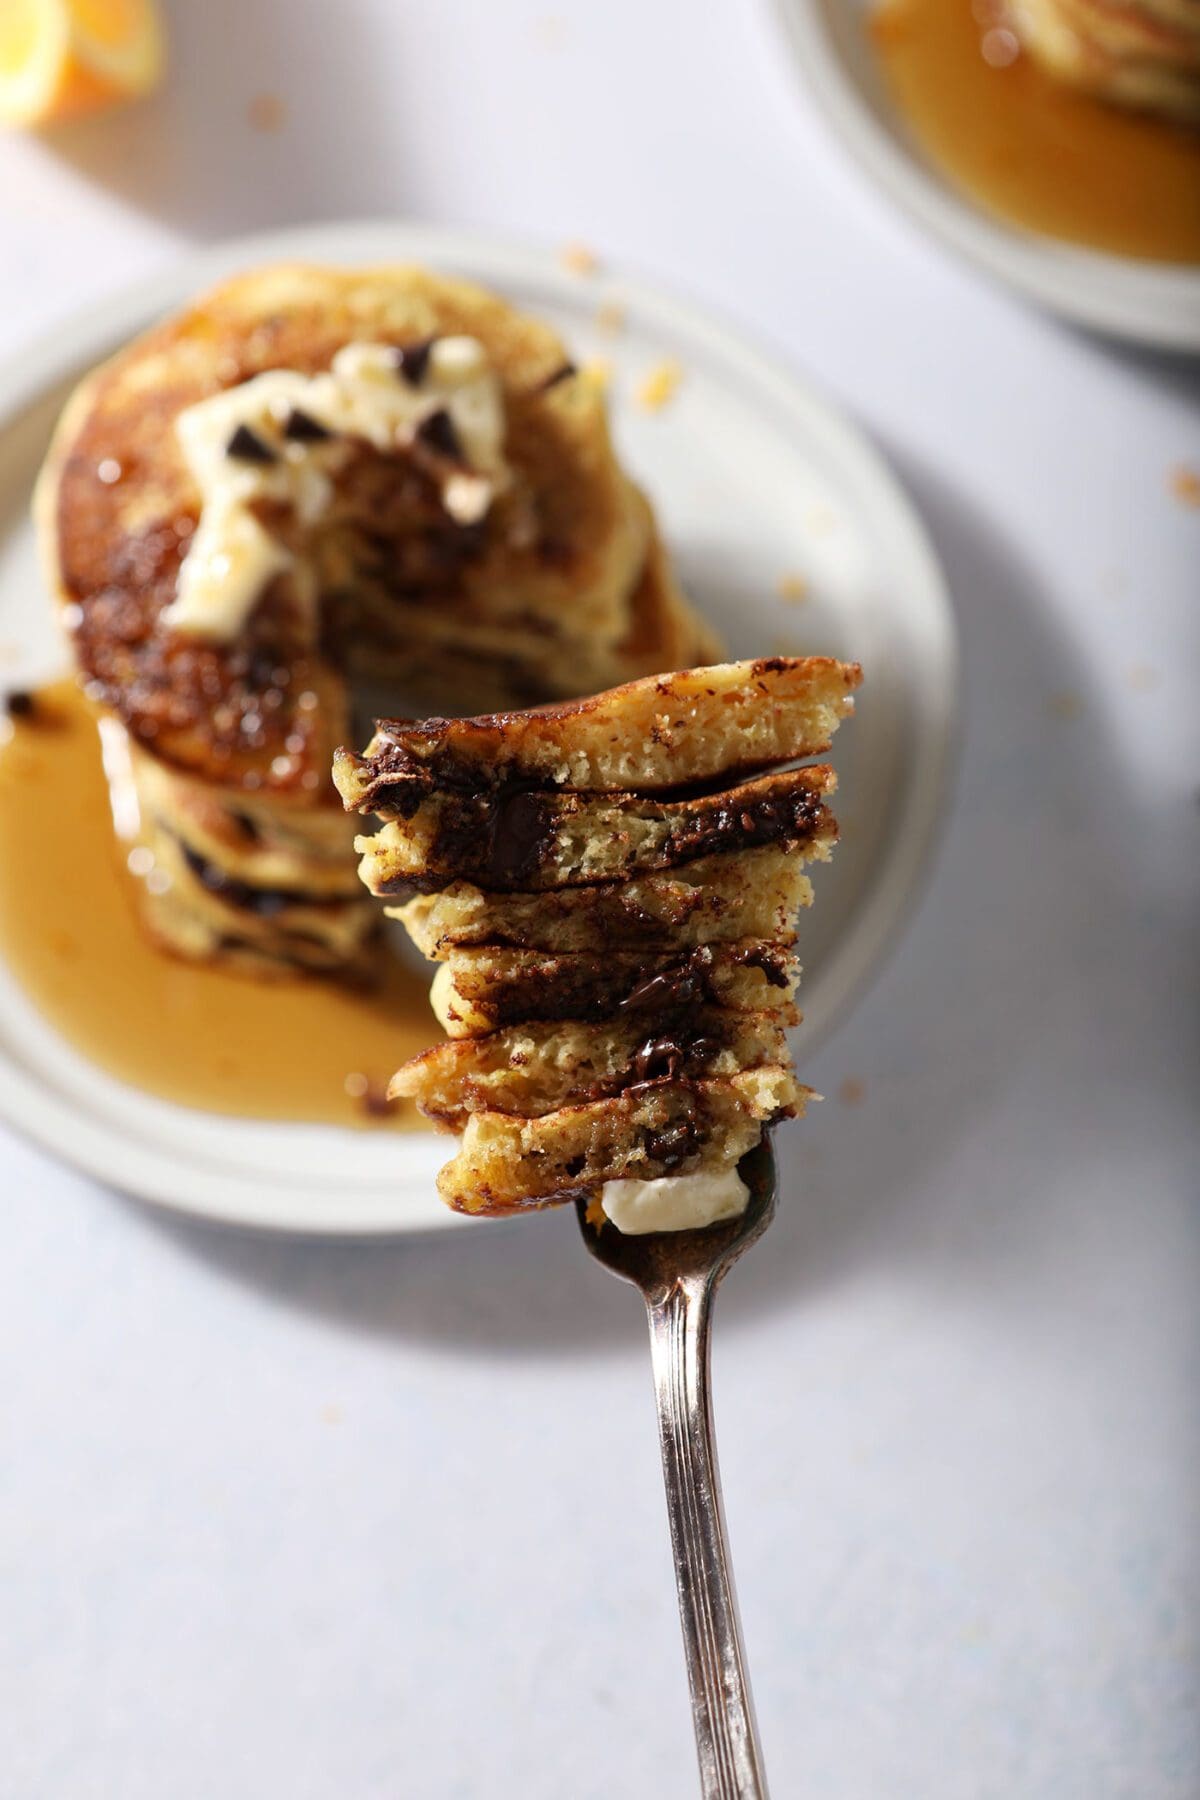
[389,1006,788,1132]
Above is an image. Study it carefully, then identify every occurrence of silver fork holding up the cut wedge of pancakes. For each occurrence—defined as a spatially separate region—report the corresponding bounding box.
[578,1134,775,1800]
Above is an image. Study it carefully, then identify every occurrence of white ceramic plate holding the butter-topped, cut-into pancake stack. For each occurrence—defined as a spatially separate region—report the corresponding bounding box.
[0,225,955,1235]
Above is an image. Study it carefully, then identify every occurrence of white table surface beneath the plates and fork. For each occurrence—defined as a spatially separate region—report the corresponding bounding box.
[0,0,1200,1800]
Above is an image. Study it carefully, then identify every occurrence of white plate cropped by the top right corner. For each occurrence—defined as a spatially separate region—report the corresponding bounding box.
[777,0,1200,351]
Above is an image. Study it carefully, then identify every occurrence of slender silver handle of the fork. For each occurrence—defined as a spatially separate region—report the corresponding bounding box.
[646,1276,766,1800]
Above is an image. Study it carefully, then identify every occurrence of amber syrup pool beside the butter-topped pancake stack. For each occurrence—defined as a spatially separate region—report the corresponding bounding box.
[0,680,439,1129]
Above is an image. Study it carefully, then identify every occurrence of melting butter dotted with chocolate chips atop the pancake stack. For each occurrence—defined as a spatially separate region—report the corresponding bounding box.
[162,337,509,643]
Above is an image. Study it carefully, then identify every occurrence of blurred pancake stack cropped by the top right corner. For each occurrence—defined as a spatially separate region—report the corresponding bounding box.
[1009,0,1200,126]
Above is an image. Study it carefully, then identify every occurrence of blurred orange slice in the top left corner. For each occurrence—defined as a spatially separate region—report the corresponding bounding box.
[0,0,162,124]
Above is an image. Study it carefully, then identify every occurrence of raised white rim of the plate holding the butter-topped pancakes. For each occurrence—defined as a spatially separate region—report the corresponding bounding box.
[0,220,959,1240]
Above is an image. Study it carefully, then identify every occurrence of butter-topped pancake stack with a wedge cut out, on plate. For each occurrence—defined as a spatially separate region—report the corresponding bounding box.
[36,265,720,970]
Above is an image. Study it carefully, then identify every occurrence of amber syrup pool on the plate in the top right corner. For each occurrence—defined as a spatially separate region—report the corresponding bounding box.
[871,0,1200,263]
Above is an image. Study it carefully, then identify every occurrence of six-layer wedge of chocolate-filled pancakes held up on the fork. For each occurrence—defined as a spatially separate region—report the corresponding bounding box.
[335,657,860,1213]
